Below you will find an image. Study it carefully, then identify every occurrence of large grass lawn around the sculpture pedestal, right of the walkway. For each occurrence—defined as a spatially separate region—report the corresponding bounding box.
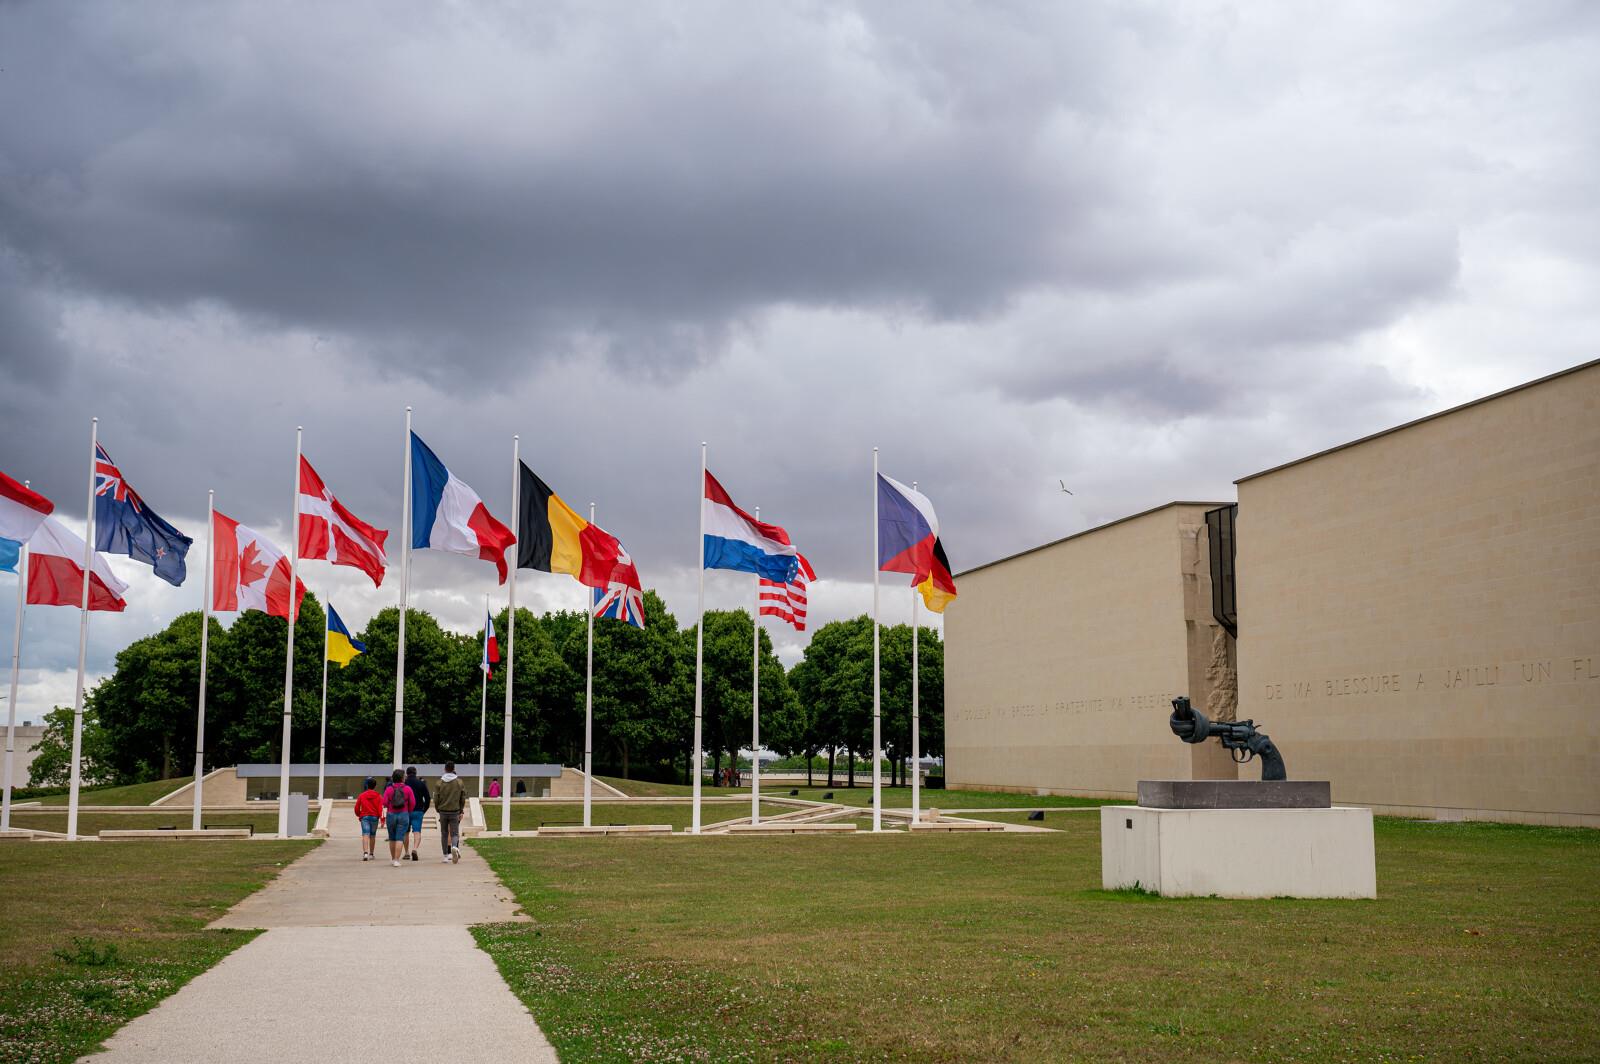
[474,813,1600,1061]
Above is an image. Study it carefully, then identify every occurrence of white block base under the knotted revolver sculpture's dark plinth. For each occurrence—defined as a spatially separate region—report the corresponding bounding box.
[1101,805,1378,898]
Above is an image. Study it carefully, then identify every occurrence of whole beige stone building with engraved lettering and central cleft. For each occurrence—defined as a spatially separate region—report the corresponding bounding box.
[946,362,1600,827]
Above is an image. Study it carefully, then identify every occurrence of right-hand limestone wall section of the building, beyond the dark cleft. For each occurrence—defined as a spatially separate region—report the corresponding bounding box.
[1235,363,1600,826]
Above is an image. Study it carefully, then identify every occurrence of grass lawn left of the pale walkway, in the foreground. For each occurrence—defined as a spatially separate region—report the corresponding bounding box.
[0,842,314,1064]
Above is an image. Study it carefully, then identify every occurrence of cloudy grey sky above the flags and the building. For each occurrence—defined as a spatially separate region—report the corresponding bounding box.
[0,0,1600,717]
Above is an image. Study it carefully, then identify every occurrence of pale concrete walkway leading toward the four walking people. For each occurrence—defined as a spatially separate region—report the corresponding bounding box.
[85,803,557,1064]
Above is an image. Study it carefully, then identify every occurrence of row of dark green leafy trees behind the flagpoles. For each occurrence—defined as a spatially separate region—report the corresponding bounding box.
[32,590,944,786]
